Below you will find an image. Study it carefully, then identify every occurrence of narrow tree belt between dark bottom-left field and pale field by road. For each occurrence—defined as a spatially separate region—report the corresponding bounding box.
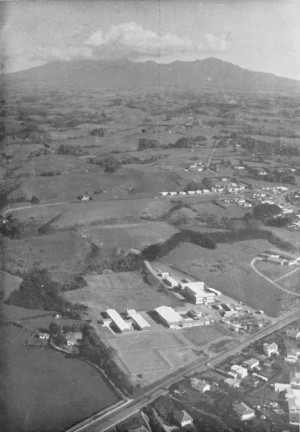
[79,325,134,394]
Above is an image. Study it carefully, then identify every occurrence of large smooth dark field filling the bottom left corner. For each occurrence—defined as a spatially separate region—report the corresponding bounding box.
[0,326,118,432]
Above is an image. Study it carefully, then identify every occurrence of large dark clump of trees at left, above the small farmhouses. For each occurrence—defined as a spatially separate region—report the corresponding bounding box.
[7,268,86,318]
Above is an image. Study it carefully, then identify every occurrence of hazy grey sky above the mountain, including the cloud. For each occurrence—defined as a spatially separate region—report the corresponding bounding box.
[0,0,300,80]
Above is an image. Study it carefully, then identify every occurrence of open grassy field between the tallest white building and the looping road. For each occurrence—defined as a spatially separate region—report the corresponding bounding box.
[162,240,294,316]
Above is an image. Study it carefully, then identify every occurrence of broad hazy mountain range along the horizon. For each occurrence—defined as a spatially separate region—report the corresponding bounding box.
[2,58,300,93]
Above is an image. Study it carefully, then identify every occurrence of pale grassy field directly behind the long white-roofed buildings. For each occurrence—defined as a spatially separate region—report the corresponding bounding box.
[64,272,180,312]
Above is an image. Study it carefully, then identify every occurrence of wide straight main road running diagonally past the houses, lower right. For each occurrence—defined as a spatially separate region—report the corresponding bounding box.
[66,307,300,432]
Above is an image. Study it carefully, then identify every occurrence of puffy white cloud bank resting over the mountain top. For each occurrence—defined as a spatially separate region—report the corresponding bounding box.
[85,21,227,59]
